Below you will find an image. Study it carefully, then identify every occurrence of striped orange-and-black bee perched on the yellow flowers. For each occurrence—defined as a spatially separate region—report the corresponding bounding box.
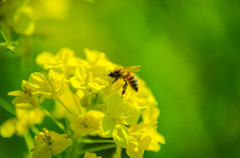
[108,66,141,96]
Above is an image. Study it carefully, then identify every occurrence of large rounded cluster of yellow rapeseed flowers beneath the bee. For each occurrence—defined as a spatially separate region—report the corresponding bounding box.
[1,48,165,158]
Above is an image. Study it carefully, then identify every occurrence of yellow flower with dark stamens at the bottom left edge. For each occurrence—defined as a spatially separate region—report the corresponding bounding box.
[31,128,72,158]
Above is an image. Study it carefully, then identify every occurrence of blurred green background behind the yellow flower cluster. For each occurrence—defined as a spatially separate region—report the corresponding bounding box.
[0,0,240,158]
